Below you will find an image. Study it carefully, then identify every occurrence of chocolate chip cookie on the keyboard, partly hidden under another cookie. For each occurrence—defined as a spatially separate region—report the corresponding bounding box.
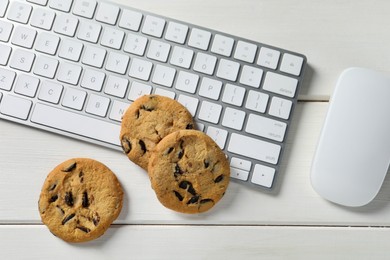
[120,95,194,170]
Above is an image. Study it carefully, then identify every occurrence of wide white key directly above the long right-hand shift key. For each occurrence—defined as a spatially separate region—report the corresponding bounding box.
[245,114,287,142]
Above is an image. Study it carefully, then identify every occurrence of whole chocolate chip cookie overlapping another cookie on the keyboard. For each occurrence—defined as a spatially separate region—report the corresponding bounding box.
[148,130,230,213]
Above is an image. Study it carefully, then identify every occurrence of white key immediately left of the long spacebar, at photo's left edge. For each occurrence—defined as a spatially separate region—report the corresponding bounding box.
[0,95,32,120]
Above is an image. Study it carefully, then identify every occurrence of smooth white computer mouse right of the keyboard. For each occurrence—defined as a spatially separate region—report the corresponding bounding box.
[311,68,390,207]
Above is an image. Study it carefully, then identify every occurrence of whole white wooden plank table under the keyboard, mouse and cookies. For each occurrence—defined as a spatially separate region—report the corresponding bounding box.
[0,0,390,260]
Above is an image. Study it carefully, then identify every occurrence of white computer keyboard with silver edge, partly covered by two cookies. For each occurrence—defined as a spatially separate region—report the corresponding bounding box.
[0,0,306,188]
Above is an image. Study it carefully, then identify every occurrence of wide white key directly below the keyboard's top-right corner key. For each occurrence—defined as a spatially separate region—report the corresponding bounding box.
[263,72,298,98]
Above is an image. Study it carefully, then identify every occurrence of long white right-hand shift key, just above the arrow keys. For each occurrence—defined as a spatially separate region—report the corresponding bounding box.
[228,133,281,164]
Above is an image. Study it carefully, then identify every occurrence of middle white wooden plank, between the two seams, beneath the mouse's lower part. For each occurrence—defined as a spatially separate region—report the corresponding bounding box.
[0,102,390,226]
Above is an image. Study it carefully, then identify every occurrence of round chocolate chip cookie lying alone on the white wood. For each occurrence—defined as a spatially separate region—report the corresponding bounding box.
[38,158,123,242]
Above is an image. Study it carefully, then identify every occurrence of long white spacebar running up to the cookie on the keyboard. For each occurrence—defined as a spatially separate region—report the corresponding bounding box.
[31,103,120,146]
